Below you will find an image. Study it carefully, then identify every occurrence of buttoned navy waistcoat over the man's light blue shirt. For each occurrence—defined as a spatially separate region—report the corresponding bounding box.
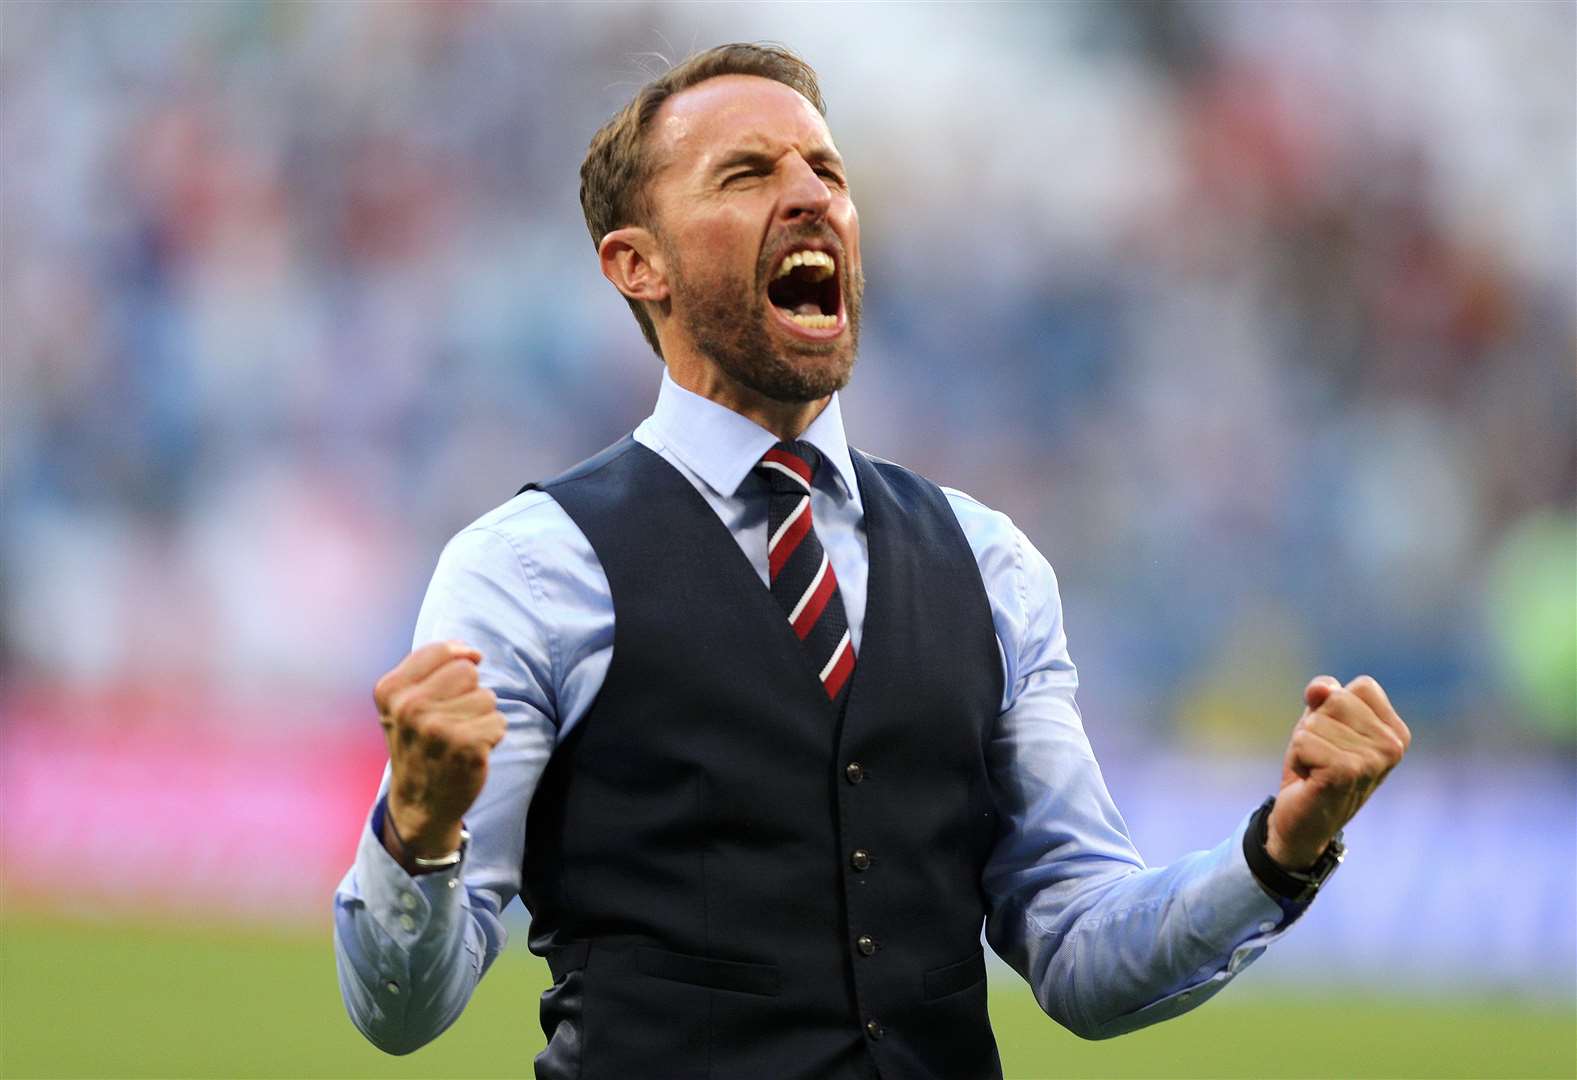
[522,437,1003,1080]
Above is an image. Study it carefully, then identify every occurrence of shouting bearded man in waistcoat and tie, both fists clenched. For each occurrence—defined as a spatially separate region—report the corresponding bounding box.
[336,46,1410,1080]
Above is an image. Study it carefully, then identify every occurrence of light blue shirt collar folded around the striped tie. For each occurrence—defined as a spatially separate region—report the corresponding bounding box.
[651,371,859,508]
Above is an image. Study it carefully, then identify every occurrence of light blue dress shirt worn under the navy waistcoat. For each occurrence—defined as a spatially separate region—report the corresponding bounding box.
[334,375,1296,1053]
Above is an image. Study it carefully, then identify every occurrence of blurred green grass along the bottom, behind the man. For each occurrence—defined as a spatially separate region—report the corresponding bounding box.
[0,918,1577,1078]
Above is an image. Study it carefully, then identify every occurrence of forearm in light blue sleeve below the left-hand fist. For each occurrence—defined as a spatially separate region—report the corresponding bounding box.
[334,800,505,1053]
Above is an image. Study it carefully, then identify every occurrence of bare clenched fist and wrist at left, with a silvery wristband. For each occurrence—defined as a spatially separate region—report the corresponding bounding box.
[372,642,505,870]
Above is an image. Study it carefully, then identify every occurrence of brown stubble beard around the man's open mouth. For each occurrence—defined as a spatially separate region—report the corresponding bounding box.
[665,236,864,404]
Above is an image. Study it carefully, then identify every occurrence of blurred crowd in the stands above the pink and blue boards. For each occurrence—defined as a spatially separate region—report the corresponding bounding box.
[0,2,1577,741]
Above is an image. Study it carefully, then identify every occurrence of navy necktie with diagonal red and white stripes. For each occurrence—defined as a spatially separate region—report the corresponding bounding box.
[755,441,855,703]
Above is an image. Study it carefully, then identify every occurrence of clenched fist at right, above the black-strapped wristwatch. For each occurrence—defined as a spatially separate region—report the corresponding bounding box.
[1265,675,1413,870]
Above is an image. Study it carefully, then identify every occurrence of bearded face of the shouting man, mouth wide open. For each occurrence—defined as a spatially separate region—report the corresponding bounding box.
[647,76,864,402]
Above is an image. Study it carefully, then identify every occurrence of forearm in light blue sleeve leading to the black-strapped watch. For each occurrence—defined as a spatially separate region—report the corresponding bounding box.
[987,818,1287,1039]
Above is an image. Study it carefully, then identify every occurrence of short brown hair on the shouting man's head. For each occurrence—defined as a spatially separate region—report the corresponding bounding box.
[580,43,826,356]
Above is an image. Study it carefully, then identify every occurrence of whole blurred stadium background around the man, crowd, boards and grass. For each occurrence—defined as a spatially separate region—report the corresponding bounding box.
[0,0,1577,1075]
